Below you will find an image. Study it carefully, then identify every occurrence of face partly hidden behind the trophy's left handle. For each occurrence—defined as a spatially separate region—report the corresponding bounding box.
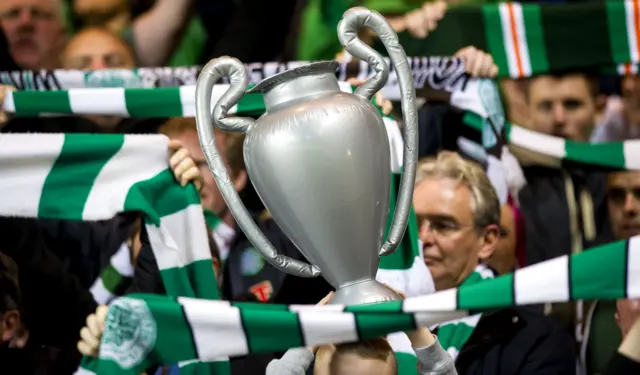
[169,130,227,216]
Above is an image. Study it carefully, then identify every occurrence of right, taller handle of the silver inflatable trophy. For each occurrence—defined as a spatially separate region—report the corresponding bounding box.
[338,7,418,256]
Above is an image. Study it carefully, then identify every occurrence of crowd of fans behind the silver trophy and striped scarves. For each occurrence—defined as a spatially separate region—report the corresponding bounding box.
[0,0,640,375]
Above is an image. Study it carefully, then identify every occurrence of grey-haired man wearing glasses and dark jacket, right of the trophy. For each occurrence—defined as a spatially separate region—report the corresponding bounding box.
[413,151,576,375]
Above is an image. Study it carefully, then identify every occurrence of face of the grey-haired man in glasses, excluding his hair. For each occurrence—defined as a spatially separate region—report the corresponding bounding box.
[413,178,493,290]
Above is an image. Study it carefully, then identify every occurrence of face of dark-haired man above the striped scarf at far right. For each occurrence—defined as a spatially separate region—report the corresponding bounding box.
[528,74,596,142]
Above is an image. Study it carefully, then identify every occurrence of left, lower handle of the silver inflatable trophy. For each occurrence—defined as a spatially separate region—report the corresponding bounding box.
[196,57,320,277]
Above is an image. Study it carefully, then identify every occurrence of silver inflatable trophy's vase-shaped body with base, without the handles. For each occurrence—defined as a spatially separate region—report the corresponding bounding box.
[244,62,397,303]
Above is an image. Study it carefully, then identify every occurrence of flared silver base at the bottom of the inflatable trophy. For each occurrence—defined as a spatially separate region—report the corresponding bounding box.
[330,280,402,305]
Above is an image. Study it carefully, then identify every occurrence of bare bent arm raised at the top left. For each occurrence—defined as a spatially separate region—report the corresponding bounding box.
[128,0,193,66]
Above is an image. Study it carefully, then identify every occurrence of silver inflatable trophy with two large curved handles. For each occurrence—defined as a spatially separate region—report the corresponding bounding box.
[196,8,418,304]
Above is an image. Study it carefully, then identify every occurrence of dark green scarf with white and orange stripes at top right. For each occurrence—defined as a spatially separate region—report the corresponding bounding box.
[376,0,640,78]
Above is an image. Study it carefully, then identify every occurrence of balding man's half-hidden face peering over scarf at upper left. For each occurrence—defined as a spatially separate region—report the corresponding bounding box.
[62,29,135,70]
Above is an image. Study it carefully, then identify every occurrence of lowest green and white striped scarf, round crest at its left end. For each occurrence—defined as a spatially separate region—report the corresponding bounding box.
[76,237,640,375]
